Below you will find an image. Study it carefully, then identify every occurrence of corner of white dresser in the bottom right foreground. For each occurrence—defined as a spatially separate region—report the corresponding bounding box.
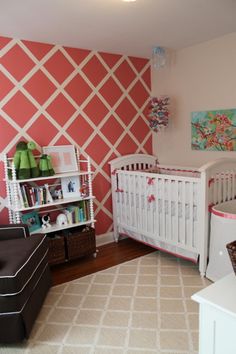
[192,273,236,354]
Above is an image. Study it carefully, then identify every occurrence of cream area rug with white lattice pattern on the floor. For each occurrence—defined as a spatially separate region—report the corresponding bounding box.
[0,251,210,354]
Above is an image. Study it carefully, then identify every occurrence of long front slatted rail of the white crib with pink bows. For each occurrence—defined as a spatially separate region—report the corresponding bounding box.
[116,170,200,251]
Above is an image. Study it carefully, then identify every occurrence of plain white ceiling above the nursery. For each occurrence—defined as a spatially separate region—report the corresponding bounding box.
[0,0,236,57]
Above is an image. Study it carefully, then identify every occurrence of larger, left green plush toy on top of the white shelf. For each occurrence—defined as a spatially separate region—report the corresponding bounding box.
[13,141,39,179]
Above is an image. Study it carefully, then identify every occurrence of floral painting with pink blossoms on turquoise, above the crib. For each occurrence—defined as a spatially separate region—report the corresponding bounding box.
[191,109,236,151]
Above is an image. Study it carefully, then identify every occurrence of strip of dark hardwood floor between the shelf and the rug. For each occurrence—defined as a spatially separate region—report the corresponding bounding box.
[51,238,154,285]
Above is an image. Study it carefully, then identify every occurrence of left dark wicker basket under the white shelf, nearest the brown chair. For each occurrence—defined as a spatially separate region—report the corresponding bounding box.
[48,236,66,265]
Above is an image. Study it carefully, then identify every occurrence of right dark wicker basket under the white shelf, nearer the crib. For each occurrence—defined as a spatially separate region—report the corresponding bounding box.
[65,226,96,260]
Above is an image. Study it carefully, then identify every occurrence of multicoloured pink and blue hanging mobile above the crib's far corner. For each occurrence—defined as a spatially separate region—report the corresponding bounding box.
[149,96,170,132]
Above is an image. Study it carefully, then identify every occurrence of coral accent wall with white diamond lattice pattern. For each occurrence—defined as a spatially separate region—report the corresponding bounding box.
[0,37,152,234]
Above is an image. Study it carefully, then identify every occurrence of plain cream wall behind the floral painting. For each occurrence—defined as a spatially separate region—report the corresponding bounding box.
[152,33,236,166]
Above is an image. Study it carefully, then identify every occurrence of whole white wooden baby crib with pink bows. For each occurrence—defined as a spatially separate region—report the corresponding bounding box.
[110,154,236,275]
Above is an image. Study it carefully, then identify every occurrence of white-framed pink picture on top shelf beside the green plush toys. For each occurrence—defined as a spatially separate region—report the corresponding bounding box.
[42,145,78,173]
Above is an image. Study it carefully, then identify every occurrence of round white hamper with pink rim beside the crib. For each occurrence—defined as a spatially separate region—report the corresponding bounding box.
[206,200,236,281]
